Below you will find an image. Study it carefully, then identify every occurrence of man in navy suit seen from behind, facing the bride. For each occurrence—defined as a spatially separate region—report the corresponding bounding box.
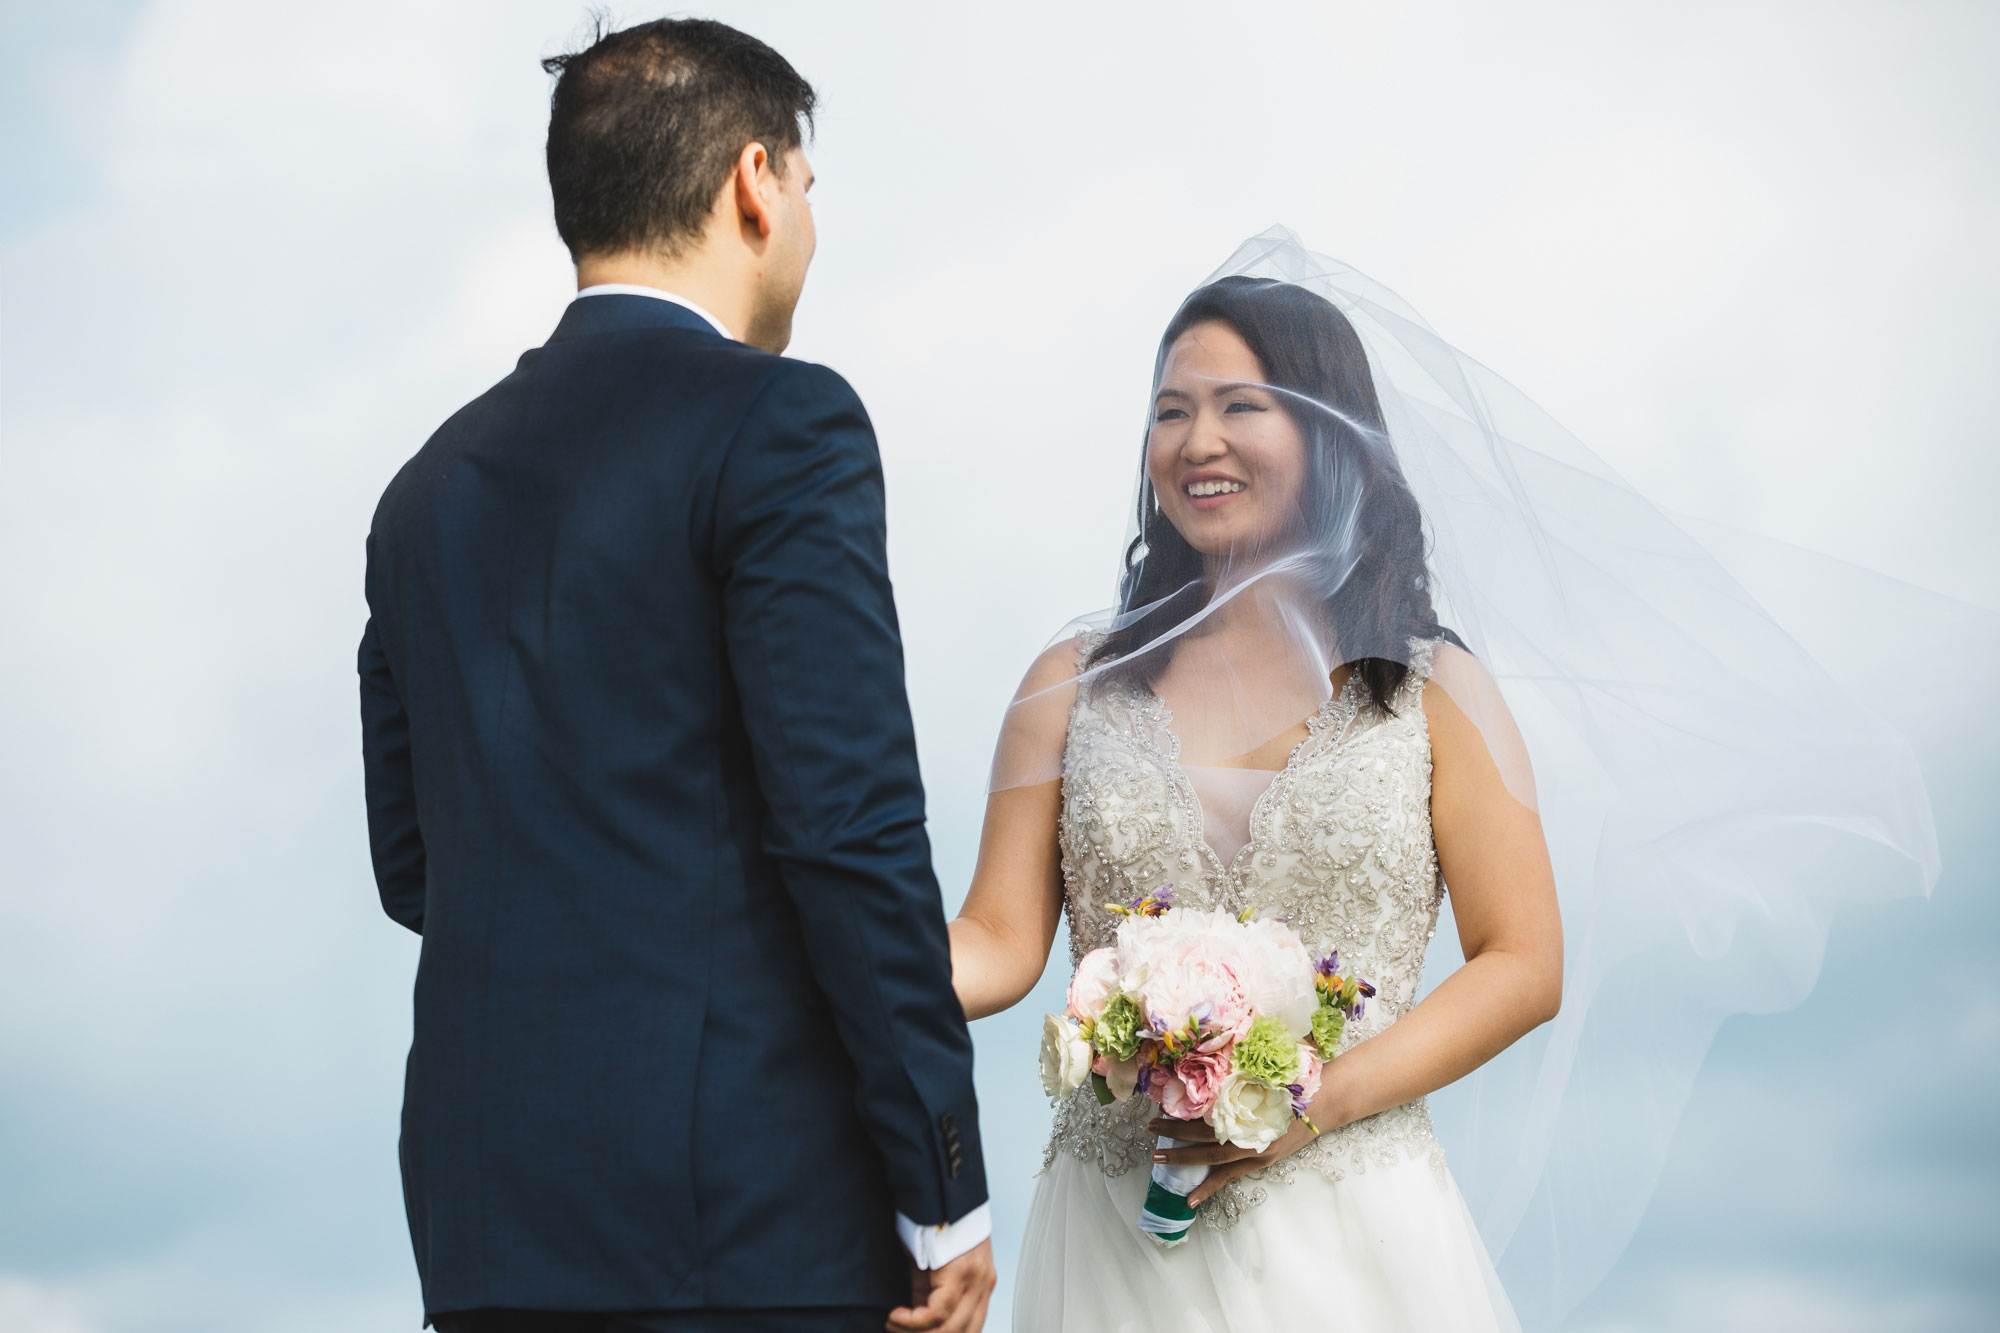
[360,20,994,1333]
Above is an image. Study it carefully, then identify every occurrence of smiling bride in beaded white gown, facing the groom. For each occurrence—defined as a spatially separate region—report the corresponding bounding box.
[952,264,1564,1333]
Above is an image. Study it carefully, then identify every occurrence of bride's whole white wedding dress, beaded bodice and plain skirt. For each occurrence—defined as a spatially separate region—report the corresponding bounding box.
[1014,634,1520,1333]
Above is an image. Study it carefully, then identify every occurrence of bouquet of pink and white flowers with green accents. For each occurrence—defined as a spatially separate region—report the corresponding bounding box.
[1042,885,1374,1245]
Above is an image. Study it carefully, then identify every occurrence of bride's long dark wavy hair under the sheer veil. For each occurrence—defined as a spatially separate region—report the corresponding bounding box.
[1086,276,1464,711]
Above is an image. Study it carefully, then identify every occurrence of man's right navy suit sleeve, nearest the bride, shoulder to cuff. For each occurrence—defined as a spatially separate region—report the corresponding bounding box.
[714,362,986,1227]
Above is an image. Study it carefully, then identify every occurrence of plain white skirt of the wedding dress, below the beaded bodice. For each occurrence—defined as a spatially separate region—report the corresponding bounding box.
[1014,1153,1520,1333]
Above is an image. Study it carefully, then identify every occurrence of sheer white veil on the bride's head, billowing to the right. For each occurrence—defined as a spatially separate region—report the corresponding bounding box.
[994,228,1938,1327]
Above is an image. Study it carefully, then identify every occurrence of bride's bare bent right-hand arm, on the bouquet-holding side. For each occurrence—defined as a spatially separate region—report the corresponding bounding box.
[1314,648,1562,1129]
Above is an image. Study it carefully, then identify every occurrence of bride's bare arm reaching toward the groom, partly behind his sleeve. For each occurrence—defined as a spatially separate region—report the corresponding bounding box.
[950,642,1076,1019]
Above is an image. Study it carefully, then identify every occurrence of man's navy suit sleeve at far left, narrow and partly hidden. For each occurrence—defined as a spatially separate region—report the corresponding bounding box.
[360,536,424,935]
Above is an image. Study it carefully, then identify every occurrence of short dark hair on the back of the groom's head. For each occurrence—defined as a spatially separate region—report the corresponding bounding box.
[542,18,816,258]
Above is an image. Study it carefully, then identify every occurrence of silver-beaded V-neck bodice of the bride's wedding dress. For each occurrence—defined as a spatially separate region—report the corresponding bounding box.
[1044,640,1444,1227]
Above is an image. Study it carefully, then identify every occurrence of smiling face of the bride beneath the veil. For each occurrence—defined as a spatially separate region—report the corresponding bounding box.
[1146,322,1306,560]
